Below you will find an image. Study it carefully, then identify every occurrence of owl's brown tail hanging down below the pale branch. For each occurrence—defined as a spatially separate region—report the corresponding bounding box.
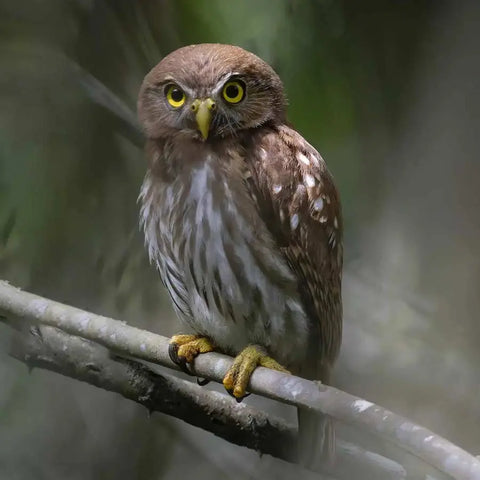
[297,408,335,469]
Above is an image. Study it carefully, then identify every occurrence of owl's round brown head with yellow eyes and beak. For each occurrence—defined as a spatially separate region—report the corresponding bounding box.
[138,44,286,141]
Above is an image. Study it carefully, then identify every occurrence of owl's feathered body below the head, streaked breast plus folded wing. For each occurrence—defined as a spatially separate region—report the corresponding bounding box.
[141,126,342,380]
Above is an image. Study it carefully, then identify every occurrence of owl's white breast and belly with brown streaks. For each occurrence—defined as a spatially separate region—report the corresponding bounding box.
[140,137,308,368]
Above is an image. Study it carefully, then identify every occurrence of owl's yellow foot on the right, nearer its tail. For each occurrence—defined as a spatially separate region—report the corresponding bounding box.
[223,345,290,401]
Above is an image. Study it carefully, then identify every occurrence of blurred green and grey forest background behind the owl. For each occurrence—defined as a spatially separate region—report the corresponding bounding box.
[0,0,480,480]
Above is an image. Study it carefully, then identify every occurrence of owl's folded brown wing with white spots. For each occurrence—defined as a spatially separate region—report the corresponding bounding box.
[247,126,343,382]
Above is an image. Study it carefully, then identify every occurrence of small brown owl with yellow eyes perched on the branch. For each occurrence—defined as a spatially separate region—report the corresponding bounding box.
[138,44,342,464]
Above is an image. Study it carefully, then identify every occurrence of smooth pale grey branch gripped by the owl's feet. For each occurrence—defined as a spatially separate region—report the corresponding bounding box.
[0,282,480,480]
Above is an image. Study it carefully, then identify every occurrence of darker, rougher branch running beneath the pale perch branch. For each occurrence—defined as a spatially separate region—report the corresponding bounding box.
[4,320,405,480]
